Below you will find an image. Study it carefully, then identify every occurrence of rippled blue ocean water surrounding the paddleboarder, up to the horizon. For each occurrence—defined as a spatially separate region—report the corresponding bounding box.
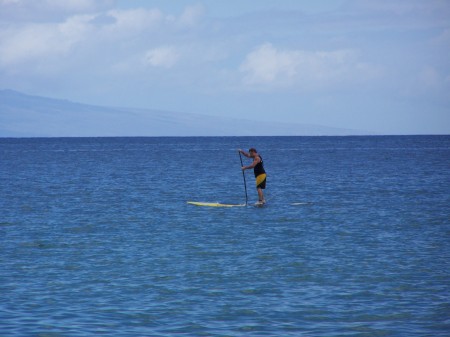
[0,136,450,337]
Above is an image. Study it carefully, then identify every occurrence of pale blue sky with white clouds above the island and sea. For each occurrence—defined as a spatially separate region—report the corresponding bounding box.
[0,0,450,134]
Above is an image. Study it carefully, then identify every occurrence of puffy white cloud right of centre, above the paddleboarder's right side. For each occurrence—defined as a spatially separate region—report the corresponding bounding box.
[240,43,381,88]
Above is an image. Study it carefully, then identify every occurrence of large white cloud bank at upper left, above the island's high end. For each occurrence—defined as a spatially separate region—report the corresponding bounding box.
[0,0,204,72]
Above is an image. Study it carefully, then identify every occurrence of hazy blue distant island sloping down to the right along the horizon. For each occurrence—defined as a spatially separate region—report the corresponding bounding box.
[0,90,364,137]
